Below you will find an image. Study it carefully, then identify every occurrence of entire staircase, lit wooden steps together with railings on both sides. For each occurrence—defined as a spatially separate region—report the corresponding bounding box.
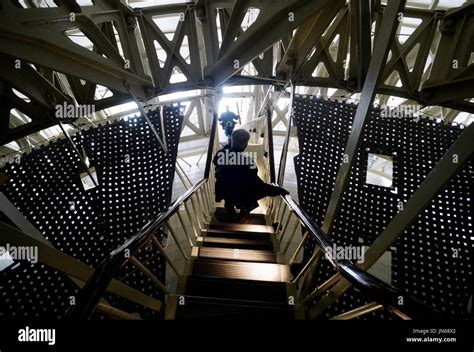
[0,109,443,320]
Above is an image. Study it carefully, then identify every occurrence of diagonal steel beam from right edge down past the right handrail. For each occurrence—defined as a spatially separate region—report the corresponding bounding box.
[309,124,474,319]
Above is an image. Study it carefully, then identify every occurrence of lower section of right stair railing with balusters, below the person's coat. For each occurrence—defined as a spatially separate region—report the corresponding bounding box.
[270,191,444,319]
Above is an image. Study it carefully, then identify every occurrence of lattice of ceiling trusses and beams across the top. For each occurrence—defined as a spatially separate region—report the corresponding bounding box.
[0,0,474,145]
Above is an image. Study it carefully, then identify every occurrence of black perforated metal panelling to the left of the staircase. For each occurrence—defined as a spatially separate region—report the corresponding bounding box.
[0,105,182,318]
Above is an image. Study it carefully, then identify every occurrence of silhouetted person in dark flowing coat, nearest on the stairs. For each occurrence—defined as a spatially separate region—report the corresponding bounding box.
[213,130,288,221]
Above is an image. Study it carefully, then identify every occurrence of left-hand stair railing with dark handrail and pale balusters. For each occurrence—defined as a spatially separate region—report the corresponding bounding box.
[67,114,217,319]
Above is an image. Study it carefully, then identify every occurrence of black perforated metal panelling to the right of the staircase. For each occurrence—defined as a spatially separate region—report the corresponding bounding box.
[294,97,474,317]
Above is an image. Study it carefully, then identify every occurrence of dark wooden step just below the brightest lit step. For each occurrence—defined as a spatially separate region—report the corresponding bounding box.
[185,276,288,303]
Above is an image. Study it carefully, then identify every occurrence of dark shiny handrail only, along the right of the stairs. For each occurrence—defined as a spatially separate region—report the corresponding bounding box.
[274,191,444,320]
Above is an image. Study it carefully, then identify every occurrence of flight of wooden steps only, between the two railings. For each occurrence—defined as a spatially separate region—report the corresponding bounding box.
[165,208,304,319]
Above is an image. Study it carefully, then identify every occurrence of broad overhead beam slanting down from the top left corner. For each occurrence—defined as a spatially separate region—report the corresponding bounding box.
[0,1,154,98]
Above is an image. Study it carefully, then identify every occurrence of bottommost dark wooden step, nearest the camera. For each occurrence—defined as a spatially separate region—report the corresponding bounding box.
[167,296,294,320]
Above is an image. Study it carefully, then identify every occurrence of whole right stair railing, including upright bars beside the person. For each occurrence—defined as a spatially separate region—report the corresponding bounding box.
[251,84,446,320]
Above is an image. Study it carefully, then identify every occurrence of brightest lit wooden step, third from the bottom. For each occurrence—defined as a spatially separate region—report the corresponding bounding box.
[192,258,290,282]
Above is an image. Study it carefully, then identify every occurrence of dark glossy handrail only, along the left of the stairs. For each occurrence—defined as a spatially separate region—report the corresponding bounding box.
[67,178,207,320]
